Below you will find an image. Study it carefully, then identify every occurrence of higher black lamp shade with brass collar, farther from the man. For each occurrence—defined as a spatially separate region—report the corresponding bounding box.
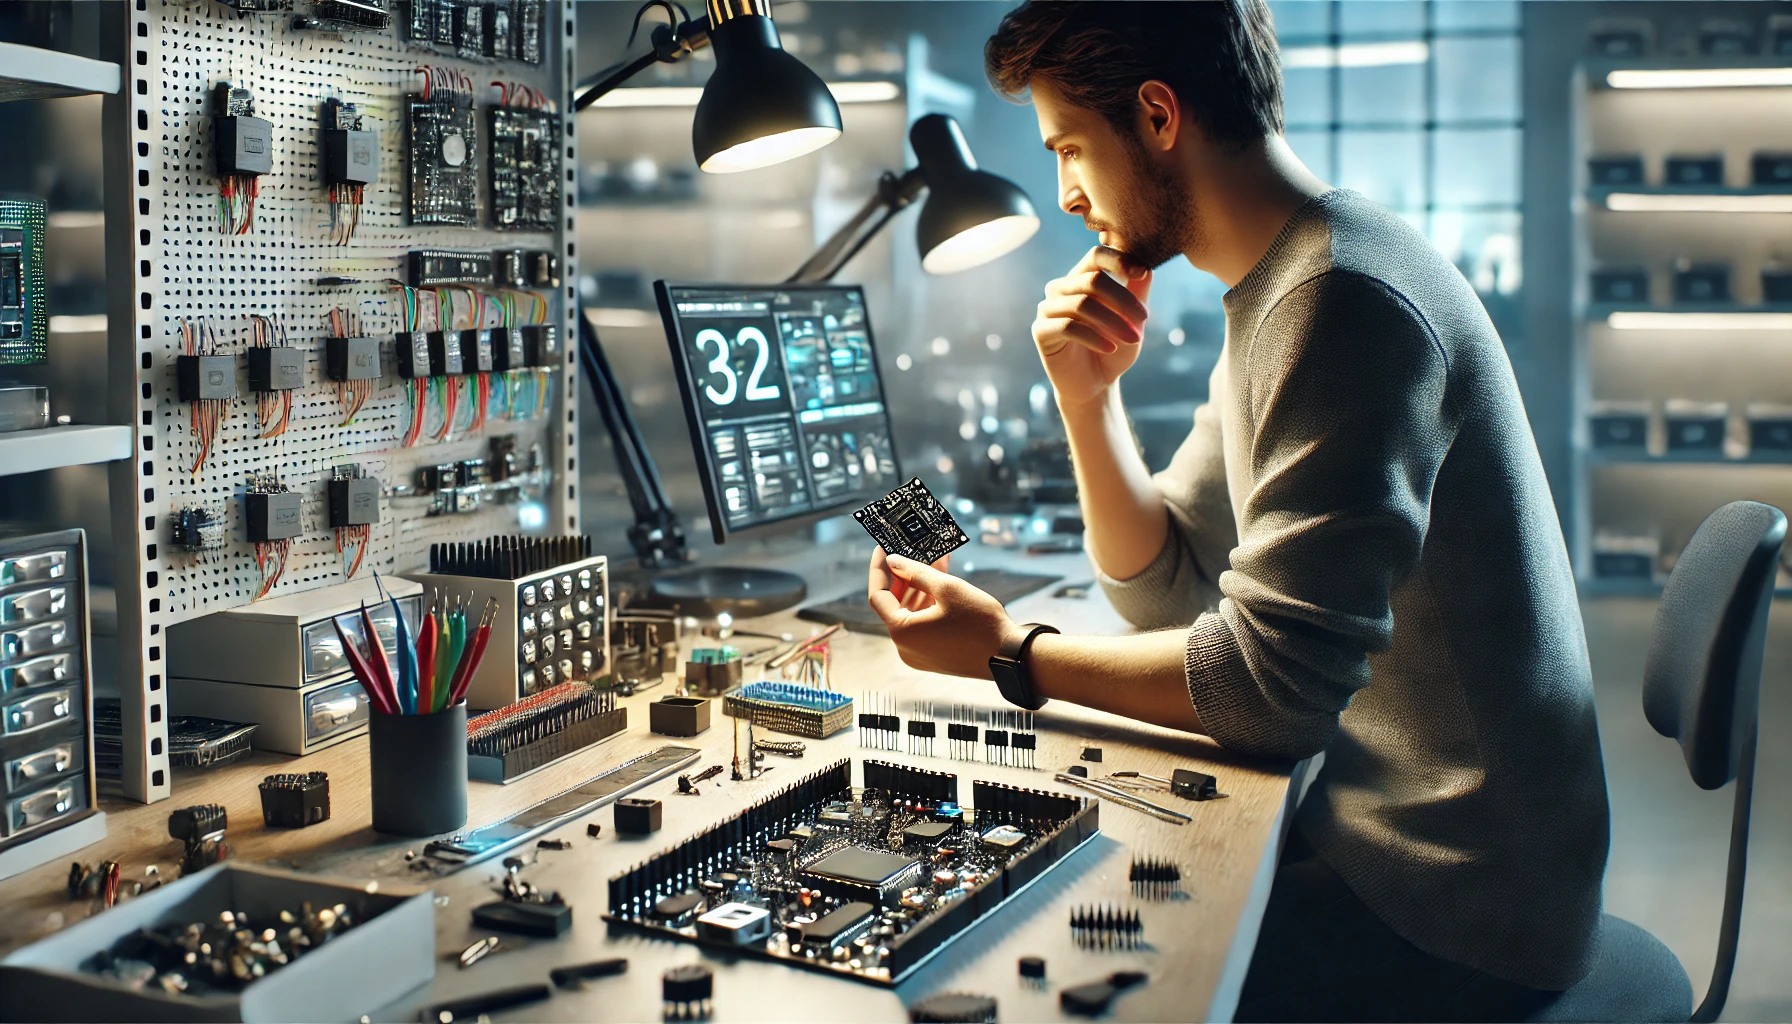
[690,9,840,174]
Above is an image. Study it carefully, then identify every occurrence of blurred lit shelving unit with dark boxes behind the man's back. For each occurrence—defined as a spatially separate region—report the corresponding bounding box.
[1568,52,1792,595]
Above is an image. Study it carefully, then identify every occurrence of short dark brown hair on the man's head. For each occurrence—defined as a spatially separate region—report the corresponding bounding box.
[984,0,1281,143]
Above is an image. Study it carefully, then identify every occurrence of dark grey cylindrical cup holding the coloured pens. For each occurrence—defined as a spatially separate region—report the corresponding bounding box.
[367,703,466,836]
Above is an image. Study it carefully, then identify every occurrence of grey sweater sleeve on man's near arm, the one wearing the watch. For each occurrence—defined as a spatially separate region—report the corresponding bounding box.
[1186,271,1455,757]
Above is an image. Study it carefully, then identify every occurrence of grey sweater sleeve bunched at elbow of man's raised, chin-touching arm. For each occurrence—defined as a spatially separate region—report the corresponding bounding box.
[1095,404,1238,629]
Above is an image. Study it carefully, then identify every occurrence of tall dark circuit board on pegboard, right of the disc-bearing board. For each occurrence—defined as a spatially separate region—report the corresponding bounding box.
[487,82,561,231]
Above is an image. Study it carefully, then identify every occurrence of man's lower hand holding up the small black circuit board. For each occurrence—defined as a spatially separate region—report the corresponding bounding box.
[867,547,1020,680]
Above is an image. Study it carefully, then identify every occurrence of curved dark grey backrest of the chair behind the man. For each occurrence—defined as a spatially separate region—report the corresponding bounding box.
[1643,502,1787,789]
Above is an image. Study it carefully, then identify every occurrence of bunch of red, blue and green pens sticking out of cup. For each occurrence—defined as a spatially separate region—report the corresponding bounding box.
[332,572,496,714]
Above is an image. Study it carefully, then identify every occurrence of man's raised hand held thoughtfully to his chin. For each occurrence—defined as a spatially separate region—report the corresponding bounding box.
[1032,246,1150,405]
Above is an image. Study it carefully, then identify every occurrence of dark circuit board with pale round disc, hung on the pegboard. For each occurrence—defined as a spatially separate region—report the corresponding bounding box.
[407,66,489,227]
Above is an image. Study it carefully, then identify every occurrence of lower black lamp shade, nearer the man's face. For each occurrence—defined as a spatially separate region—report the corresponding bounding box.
[910,114,1039,274]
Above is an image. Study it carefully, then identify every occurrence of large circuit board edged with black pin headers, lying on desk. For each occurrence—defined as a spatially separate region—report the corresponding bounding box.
[607,759,1100,986]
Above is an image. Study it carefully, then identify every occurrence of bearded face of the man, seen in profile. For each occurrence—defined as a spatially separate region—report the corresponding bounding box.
[1030,79,1195,269]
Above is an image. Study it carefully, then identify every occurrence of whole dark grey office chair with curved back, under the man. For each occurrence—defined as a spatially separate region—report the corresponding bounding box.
[1530,502,1787,1022]
